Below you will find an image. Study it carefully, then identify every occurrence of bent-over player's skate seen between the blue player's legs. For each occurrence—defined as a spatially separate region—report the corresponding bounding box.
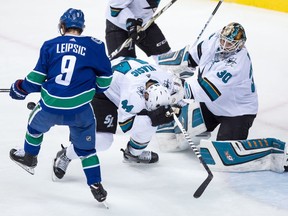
[52,145,71,181]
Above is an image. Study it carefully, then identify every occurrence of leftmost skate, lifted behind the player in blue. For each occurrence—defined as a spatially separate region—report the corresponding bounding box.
[10,149,37,175]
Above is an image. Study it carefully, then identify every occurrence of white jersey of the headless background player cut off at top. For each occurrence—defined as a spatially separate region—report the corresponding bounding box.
[106,0,160,30]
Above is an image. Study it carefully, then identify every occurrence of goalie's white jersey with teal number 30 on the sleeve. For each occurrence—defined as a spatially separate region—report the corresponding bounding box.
[185,33,258,117]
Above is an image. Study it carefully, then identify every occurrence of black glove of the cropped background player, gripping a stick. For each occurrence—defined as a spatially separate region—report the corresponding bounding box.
[126,18,146,42]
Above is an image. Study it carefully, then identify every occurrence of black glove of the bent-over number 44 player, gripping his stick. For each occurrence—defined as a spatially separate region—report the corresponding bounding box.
[138,105,181,127]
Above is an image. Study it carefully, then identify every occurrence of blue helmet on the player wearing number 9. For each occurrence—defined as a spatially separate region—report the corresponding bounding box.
[60,8,85,31]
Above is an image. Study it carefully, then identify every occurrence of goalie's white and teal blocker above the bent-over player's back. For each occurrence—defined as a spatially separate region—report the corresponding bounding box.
[157,45,195,78]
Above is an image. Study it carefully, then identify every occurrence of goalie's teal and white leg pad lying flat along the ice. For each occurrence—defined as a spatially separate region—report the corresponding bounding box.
[199,138,288,173]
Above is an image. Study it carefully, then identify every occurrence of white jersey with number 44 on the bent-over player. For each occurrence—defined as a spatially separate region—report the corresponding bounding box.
[105,57,174,122]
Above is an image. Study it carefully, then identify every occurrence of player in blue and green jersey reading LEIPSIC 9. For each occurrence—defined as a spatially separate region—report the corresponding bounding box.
[10,8,112,202]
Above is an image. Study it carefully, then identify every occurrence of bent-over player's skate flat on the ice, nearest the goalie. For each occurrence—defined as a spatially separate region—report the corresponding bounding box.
[121,145,159,164]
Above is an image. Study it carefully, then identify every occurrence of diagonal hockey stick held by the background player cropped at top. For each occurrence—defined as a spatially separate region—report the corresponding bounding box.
[108,0,177,59]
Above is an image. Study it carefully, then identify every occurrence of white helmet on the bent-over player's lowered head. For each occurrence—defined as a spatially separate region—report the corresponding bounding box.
[145,83,170,111]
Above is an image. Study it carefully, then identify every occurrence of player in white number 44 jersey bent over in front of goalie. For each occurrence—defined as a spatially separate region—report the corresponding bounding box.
[54,57,183,178]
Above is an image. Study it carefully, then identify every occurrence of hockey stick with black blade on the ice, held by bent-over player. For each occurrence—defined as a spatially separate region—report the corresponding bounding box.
[172,111,213,198]
